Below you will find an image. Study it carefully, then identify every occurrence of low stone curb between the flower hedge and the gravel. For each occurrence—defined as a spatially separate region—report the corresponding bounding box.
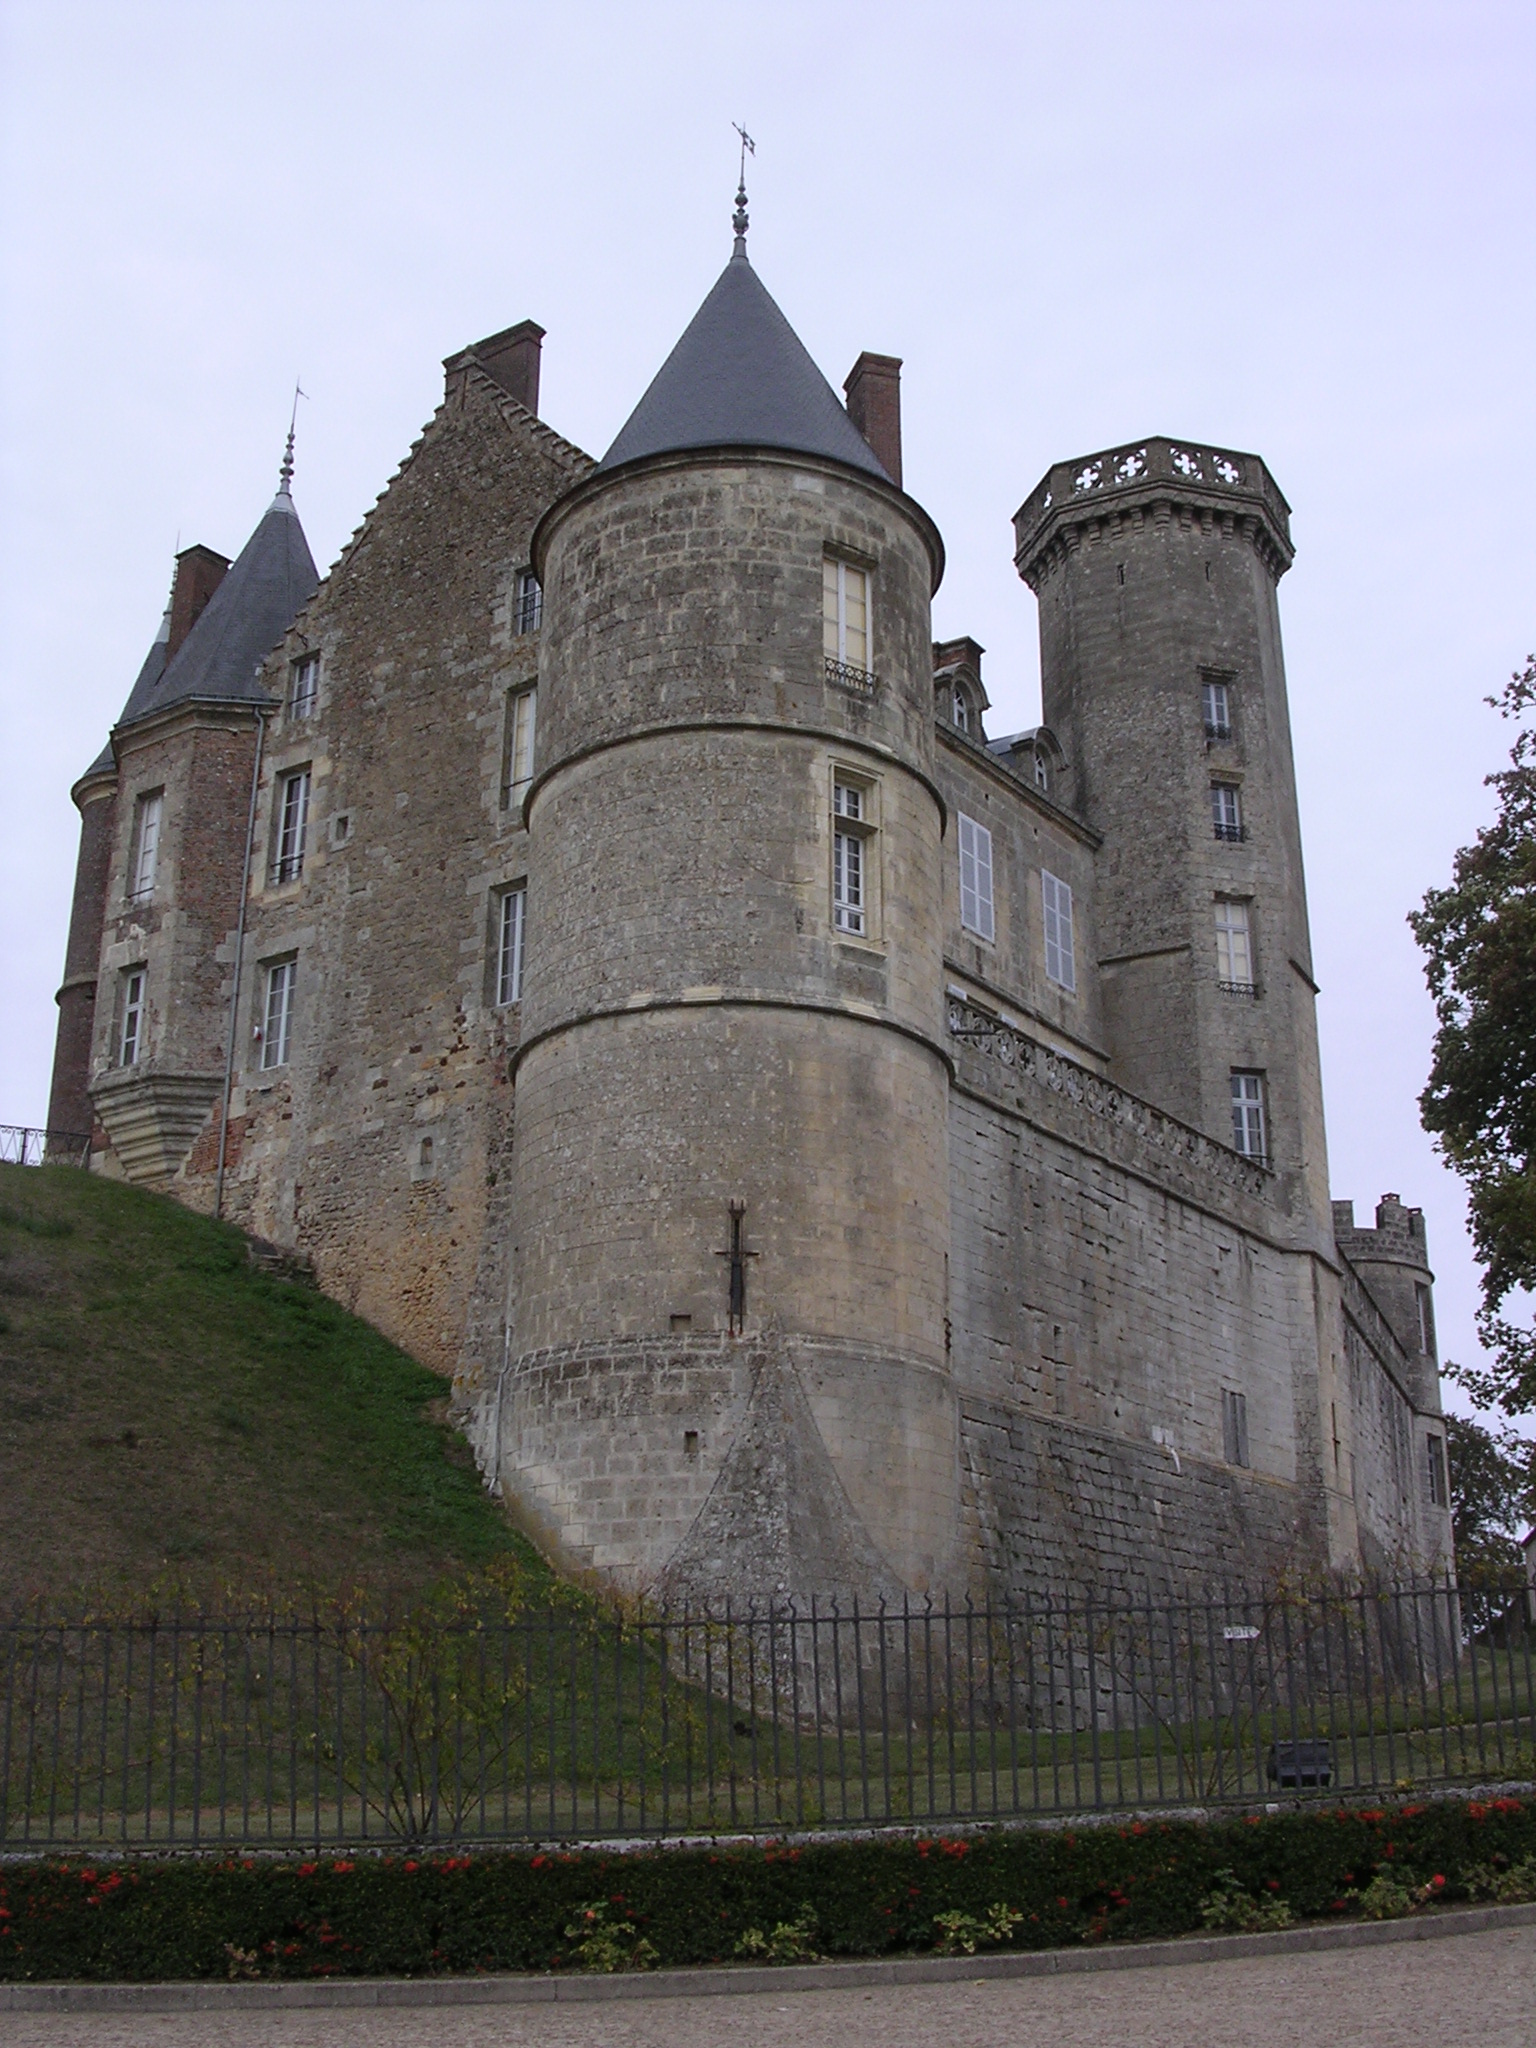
[0,1905,1536,2013]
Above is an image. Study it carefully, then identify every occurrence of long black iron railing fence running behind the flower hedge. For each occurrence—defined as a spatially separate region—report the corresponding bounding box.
[0,1581,1536,1851]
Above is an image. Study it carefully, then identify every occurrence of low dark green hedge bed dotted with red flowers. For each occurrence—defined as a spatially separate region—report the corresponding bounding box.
[0,1796,1536,1982]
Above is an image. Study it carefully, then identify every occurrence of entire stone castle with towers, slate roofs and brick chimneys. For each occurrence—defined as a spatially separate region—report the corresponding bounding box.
[49,211,1450,1599]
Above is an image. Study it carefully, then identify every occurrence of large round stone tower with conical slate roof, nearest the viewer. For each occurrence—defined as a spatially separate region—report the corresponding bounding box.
[498,220,958,1595]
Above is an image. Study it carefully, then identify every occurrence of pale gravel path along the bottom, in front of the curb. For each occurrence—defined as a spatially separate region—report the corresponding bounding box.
[0,1927,1536,2048]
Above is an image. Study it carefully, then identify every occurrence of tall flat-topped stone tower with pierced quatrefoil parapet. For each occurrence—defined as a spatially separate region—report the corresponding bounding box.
[1014,438,1331,1245]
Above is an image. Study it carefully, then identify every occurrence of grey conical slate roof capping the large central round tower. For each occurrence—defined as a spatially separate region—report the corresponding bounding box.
[598,242,891,483]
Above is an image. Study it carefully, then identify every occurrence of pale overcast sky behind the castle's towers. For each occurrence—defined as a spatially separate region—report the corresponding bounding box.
[0,0,1536,1417]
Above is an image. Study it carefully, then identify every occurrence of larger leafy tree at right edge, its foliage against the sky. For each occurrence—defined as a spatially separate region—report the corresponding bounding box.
[1409,655,1536,1415]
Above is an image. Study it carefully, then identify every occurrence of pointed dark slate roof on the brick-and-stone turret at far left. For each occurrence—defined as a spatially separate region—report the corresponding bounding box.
[117,479,319,725]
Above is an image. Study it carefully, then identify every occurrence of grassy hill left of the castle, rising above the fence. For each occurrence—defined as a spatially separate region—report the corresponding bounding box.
[0,1165,532,1610]
